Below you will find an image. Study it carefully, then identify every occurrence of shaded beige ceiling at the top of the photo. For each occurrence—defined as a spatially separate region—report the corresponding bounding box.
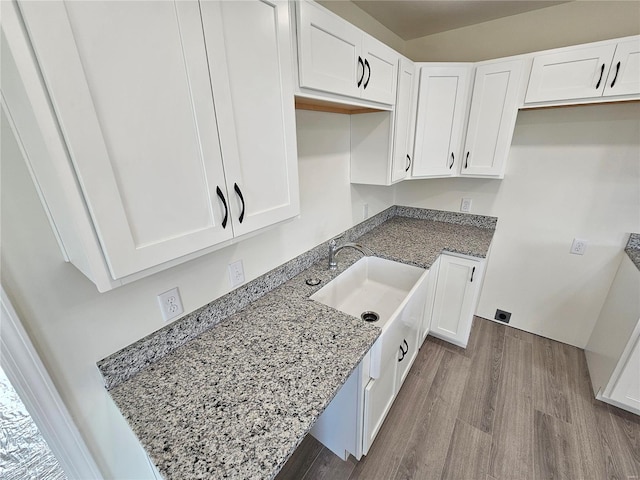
[352,0,567,40]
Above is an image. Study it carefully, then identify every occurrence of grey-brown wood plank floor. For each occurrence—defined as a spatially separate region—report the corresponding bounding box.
[276,318,640,480]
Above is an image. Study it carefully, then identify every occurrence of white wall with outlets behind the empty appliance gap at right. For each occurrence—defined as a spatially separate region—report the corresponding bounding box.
[396,103,640,347]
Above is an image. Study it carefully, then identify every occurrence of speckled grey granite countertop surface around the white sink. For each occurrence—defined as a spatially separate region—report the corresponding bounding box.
[105,207,495,480]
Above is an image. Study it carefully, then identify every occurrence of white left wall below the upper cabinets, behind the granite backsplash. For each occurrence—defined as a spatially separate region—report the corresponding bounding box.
[0,111,393,479]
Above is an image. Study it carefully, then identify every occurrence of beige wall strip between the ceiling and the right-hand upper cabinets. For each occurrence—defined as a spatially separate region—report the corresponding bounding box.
[404,0,640,62]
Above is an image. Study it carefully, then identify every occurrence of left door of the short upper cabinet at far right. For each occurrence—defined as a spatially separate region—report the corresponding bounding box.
[525,44,615,103]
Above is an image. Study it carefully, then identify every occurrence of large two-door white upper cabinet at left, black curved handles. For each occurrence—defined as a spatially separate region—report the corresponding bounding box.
[20,0,299,290]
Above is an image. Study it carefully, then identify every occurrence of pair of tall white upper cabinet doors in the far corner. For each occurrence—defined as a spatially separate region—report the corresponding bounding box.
[411,60,524,178]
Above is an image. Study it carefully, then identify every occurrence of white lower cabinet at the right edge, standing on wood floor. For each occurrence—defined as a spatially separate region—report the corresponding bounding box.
[585,254,640,415]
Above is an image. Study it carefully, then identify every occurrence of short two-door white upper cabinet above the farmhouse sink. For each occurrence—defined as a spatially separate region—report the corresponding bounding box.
[296,1,399,105]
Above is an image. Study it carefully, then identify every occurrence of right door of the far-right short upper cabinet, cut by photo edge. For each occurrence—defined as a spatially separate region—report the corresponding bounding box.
[604,38,640,97]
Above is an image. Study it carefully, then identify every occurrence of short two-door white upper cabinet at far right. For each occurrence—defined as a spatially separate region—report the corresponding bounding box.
[525,37,640,104]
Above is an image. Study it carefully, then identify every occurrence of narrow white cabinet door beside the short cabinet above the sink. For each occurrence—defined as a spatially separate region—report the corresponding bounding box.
[391,59,415,183]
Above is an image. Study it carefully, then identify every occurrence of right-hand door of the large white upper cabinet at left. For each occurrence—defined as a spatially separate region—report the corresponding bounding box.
[201,0,300,236]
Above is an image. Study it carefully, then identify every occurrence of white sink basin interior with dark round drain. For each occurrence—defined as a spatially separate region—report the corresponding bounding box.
[310,257,424,328]
